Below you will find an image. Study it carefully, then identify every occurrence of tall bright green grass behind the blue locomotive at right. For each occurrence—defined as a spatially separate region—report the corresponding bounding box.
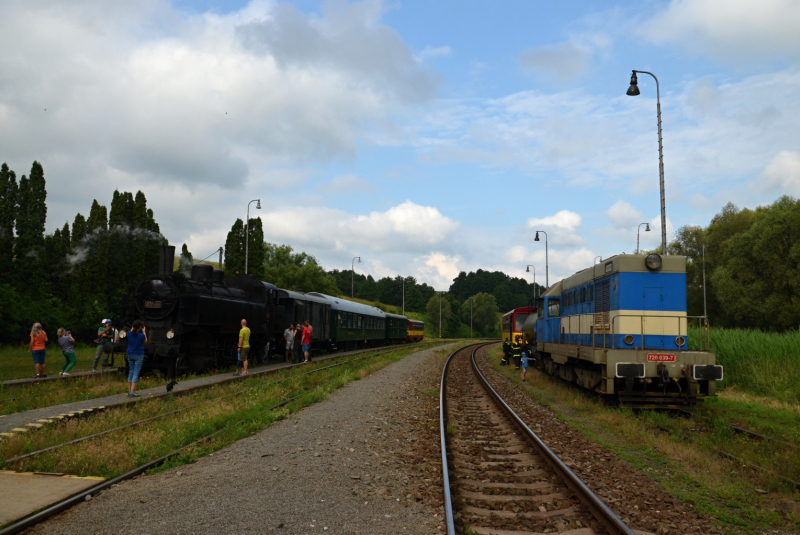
[689,328,800,404]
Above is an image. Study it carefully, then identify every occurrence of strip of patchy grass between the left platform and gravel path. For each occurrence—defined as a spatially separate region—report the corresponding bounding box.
[0,347,450,478]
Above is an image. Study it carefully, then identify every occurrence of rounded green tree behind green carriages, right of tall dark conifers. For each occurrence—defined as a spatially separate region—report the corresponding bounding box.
[261,243,339,296]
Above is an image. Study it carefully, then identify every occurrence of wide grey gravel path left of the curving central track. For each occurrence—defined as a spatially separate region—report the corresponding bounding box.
[27,349,454,535]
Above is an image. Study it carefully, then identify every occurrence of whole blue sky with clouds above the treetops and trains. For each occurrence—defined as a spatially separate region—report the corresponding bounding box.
[0,0,800,290]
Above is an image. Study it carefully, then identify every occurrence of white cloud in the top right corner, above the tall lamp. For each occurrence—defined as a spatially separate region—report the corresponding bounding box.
[639,0,800,61]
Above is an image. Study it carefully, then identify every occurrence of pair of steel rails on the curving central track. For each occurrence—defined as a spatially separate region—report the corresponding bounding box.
[439,344,634,535]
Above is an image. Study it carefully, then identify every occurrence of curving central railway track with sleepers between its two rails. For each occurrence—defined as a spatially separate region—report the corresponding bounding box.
[439,344,634,535]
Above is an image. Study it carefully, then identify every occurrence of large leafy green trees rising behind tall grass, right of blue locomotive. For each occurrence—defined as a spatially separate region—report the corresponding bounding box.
[668,196,800,331]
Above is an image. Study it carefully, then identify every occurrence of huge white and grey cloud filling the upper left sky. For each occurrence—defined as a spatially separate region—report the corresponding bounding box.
[0,0,438,188]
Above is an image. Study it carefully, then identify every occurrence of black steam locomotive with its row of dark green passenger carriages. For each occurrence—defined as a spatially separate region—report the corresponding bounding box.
[119,245,422,379]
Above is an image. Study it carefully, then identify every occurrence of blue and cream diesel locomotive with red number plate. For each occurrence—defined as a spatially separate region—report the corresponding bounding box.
[525,254,723,409]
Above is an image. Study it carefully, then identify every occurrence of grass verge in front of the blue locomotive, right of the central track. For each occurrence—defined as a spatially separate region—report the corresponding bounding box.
[489,348,800,533]
